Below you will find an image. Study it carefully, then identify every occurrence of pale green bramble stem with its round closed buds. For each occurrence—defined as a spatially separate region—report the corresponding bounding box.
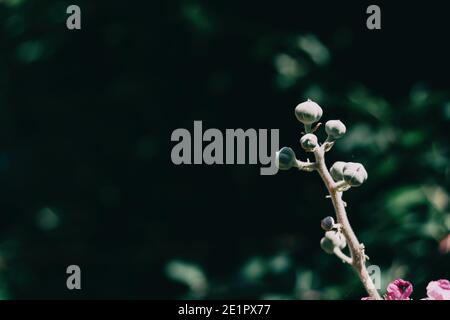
[275,99,382,300]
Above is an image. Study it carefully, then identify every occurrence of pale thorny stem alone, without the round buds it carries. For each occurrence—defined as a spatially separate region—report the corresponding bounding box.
[313,145,382,300]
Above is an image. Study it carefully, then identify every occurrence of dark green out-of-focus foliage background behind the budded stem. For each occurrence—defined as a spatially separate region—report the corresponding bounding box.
[0,0,450,299]
